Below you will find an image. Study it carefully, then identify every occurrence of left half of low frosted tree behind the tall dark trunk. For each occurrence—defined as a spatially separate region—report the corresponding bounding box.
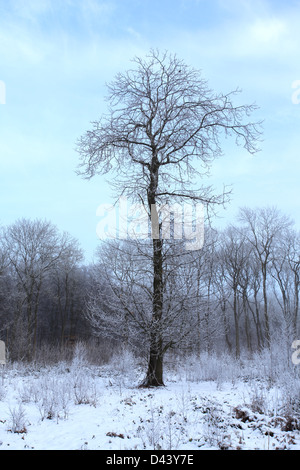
[86,240,151,347]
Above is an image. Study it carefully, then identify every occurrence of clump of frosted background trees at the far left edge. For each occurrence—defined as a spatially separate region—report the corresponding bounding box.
[0,219,88,360]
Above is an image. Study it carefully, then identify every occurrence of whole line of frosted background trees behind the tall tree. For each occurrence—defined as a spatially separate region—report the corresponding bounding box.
[0,208,300,360]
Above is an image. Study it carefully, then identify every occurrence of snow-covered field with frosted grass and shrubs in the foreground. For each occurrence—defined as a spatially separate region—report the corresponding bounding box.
[0,346,300,451]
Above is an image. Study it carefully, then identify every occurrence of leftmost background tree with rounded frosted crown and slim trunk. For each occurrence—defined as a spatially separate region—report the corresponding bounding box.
[4,219,79,359]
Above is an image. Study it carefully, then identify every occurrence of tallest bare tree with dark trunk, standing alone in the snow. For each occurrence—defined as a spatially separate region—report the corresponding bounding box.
[78,50,260,386]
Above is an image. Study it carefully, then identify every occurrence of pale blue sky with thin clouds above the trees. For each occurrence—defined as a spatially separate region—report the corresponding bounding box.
[0,0,300,262]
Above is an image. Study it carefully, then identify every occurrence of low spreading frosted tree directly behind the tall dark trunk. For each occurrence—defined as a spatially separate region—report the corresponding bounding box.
[86,239,203,364]
